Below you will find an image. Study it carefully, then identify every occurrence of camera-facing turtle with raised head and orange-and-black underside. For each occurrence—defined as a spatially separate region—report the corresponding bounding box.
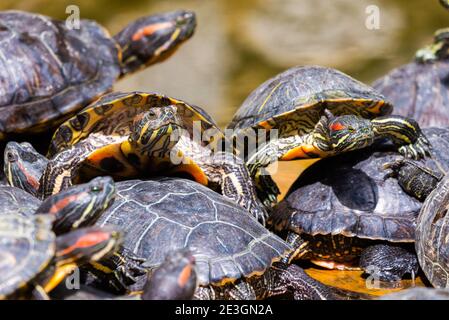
[38,92,267,223]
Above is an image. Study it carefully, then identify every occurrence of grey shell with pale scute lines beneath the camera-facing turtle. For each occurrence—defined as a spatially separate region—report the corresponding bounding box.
[97,178,291,285]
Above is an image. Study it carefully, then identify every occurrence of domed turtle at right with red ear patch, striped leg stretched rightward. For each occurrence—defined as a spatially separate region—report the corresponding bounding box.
[227,66,429,204]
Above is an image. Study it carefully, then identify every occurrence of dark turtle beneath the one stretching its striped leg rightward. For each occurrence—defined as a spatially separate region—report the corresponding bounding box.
[269,128,449,282]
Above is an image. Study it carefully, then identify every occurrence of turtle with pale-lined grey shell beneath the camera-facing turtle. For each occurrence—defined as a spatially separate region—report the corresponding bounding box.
[81,178,350,299]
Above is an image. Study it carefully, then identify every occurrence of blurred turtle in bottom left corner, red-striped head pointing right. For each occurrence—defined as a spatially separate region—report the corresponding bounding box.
[0,213,121,299]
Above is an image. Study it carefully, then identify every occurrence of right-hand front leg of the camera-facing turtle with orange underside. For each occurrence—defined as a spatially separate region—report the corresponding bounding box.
[202,152,268,225]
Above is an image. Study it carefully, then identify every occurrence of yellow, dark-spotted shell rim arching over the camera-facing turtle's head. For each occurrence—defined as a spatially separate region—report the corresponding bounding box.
[48,91,219,157]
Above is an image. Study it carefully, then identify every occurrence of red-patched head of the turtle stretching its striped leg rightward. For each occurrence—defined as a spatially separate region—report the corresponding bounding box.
[326,111,375,153]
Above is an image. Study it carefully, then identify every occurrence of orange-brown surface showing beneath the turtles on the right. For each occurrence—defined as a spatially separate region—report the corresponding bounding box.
[269,160,425,296]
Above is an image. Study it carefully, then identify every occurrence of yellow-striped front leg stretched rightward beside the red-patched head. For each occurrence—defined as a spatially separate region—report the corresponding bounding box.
[371,116,431,160]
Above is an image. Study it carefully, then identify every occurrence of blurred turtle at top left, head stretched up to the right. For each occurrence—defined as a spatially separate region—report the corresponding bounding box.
[0,11,196,139]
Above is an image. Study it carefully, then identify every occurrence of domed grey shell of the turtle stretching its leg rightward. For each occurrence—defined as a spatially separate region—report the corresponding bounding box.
[228,66,392,134]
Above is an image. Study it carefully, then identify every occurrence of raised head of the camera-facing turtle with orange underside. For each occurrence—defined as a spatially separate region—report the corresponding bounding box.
[129,105,182,157]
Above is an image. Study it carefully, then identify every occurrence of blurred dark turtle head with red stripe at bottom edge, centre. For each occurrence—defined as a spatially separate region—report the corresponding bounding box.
[142,249,197,300]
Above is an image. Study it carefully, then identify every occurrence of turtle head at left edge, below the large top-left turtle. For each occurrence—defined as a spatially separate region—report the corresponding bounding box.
[3,141,48,196]
